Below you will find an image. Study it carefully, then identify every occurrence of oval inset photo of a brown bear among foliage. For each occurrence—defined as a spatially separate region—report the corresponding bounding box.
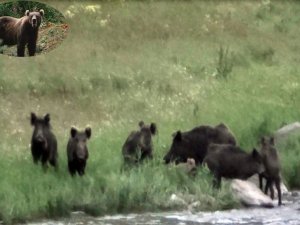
[0,1,69,57]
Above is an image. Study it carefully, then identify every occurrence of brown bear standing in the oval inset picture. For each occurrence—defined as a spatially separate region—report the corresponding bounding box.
[0,9,45,57]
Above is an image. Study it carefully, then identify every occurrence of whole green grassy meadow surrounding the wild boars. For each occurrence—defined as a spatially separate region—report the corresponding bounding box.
[0,1,300,223]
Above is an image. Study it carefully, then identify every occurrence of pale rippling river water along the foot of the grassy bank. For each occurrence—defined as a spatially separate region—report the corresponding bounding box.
[30,192,300,225]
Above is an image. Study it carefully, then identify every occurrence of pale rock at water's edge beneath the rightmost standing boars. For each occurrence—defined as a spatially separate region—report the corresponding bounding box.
[231,179,274,208]
